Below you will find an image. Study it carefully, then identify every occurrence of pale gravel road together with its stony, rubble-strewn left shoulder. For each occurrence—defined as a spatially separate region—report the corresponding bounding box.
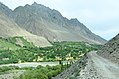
[77,51,119,79]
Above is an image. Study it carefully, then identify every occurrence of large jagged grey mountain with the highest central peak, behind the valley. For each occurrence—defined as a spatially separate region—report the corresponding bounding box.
[9,2,106,44]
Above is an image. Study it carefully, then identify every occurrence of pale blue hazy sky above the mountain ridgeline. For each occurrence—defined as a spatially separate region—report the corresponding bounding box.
[0,0,119,40]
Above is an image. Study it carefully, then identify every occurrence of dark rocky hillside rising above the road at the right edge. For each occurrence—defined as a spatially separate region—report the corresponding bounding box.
[98,34,119,64]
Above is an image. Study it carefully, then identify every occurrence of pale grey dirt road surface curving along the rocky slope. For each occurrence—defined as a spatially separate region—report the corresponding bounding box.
[82,51,119,79]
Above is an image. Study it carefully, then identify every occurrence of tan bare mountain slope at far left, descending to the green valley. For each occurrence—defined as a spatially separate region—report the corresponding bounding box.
[0,3,51,47]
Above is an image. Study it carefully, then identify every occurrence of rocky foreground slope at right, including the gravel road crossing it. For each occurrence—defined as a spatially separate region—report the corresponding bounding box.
[53,34,119,79]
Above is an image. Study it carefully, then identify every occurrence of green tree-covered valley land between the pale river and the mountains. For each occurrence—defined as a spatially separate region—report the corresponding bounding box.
[0,37,101,64]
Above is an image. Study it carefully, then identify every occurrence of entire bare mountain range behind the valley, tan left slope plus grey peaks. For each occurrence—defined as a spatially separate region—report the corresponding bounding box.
[0,2,106,46]
